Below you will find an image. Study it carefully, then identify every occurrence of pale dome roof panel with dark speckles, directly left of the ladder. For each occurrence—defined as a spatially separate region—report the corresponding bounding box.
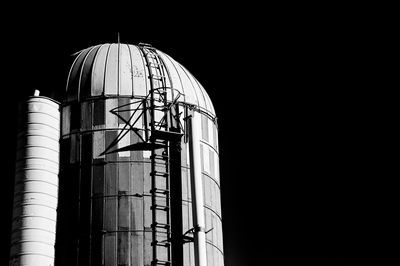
[128,45,148,96]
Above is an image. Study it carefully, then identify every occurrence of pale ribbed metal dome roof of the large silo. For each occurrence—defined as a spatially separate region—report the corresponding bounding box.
[66,43,215,116]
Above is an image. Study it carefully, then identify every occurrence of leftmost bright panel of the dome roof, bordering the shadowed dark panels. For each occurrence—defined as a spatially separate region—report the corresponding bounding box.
[91,44,110,96]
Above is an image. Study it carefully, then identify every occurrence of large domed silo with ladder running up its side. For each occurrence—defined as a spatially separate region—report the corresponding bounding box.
[56,43,223,266]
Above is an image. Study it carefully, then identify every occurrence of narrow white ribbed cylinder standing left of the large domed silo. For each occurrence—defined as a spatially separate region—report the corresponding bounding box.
[9,96,60,266]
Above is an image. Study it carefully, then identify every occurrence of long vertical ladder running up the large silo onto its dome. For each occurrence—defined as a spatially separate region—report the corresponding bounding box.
[141,44,171,266]
